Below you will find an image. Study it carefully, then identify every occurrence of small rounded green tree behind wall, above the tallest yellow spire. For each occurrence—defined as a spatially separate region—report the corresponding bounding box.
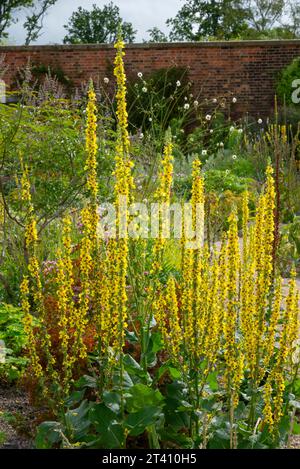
[64,2,136,44]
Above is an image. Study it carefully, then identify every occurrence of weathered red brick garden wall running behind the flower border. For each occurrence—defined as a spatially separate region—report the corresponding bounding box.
[0,40,300,117]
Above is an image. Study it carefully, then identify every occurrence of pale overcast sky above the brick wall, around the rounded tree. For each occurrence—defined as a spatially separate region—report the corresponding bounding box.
[9,0,182,45]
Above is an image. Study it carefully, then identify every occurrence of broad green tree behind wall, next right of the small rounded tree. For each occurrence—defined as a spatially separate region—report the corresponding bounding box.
[167,0,247,41]
